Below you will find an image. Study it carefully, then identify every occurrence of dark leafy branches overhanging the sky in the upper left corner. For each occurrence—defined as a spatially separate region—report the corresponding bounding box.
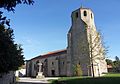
[0,0,34,26]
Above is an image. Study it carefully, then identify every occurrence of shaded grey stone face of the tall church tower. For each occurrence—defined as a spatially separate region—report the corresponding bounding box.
[67,9,90,76]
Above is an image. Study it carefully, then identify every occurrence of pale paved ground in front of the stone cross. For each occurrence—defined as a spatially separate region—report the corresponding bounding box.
[17,77,58,84]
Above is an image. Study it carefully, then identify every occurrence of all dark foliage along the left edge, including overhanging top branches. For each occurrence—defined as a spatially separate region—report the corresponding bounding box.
[0,0,34,74]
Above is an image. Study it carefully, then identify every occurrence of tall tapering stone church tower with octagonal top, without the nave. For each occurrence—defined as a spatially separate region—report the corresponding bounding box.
[67,8,107,76]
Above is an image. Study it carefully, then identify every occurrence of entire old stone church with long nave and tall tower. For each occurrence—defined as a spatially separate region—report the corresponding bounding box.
[26,7,107,77]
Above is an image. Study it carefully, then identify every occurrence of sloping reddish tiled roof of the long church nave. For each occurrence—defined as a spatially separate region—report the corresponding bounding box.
[31,49,67,60]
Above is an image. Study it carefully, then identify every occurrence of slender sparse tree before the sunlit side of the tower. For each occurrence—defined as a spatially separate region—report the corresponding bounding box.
[87,27,107,77]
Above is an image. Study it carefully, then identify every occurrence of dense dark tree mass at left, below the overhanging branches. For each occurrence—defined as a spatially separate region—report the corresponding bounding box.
[0,24,24,73]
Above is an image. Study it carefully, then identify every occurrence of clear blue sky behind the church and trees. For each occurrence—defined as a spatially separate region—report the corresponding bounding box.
[4,0,120,60]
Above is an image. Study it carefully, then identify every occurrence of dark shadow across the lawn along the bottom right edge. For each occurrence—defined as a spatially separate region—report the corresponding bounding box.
[52,77,120,84]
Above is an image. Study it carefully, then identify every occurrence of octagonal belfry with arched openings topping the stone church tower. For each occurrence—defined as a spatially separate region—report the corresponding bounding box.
[71,7,96,30]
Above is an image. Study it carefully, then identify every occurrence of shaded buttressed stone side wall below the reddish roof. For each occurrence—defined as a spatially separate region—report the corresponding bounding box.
[26,52,67,77]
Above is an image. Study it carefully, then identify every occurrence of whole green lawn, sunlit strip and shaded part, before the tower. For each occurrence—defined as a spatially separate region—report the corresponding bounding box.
[52,73,120,84]
